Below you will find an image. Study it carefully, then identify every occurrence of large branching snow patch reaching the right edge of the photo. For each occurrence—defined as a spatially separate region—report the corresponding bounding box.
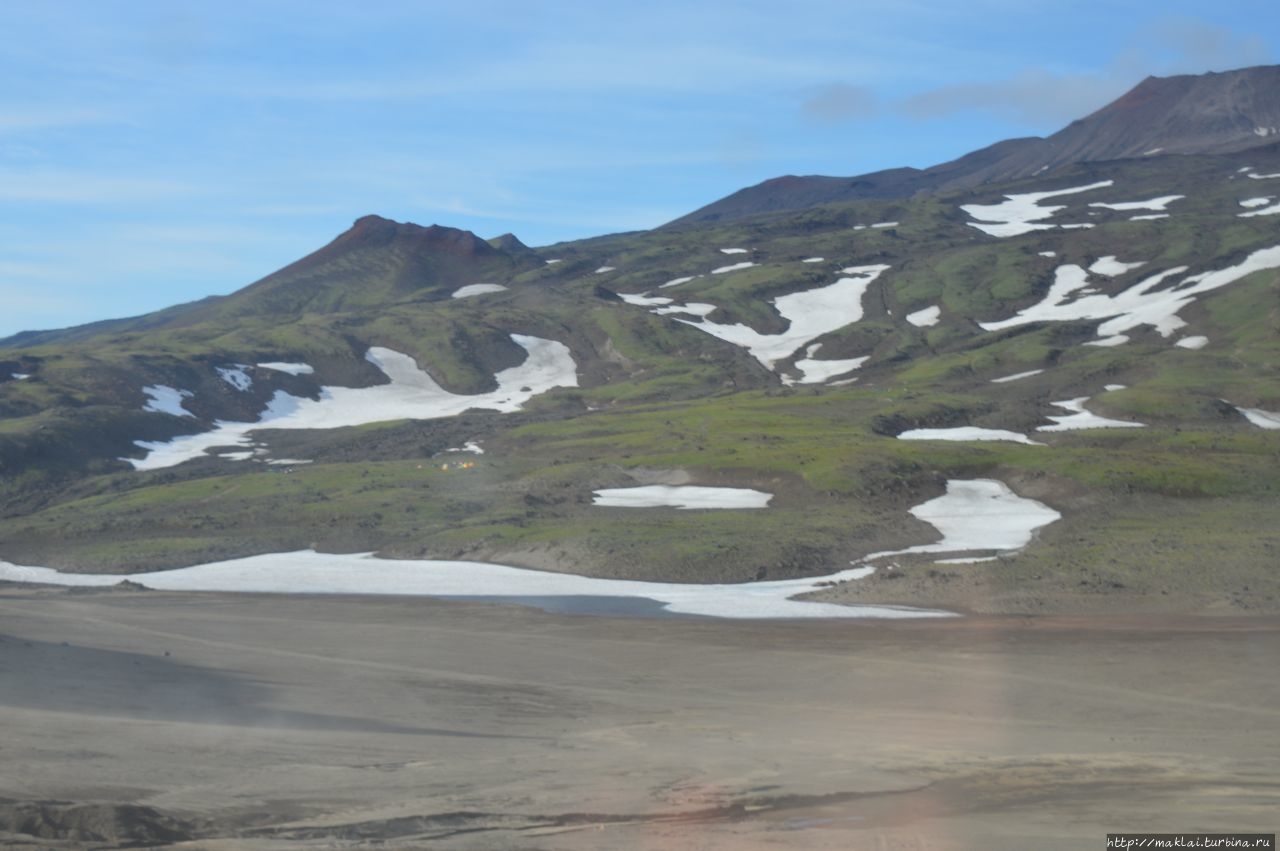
[978,246,1280,344]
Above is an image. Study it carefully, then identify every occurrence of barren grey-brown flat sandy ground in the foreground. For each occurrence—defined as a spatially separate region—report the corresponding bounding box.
[0,585,1280,851]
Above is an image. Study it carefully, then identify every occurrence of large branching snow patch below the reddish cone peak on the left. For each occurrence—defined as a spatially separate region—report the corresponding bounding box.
[122,334,577,470]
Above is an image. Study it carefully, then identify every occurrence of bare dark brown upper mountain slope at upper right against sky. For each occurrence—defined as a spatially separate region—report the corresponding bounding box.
[666,65,1280,227]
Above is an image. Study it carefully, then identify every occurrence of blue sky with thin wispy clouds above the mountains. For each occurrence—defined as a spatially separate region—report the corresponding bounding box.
[0,0,1280,338]
